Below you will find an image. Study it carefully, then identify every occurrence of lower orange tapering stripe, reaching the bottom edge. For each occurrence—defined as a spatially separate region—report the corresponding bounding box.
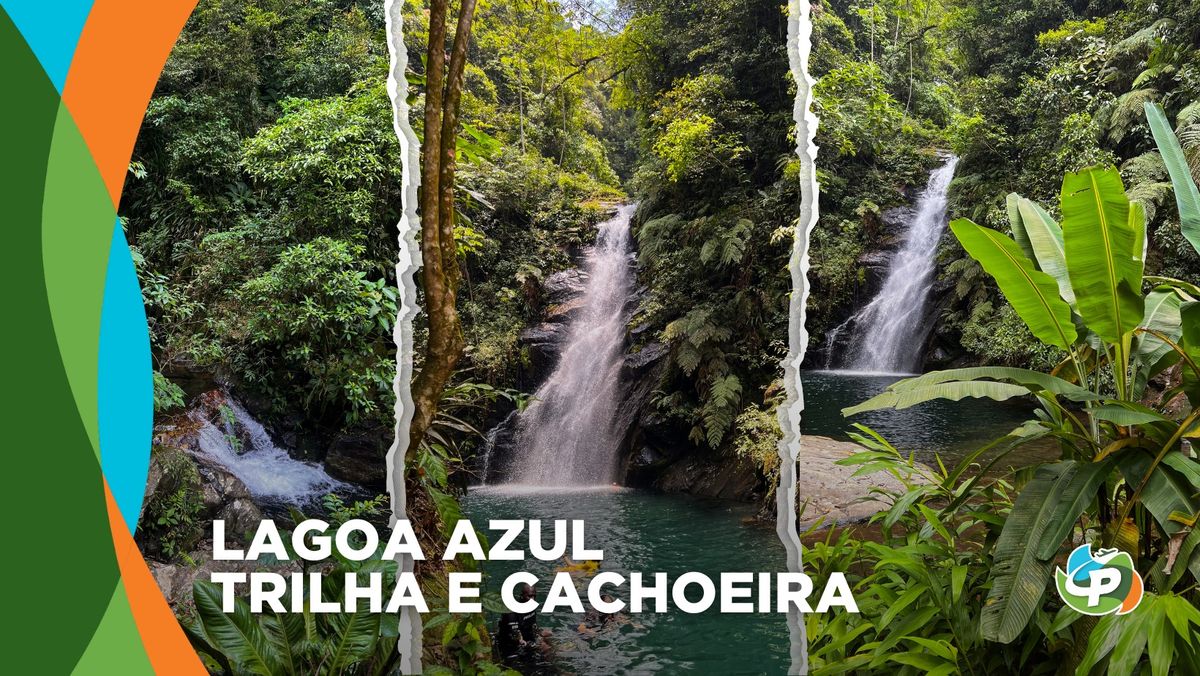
[104,479,208,676]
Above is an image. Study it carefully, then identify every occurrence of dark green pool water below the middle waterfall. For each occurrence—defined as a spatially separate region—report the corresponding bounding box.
[464,489,788,674]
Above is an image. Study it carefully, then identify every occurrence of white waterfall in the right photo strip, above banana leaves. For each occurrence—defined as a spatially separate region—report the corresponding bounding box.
[827,156,959,373]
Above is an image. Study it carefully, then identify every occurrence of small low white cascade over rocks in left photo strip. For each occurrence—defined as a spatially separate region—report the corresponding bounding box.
[192,399,349,504]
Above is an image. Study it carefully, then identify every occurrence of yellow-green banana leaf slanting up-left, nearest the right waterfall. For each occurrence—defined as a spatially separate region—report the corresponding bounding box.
[950,219,1075,349]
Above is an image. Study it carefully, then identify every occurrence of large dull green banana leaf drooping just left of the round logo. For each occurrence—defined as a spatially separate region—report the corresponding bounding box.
[980,460,1094,644]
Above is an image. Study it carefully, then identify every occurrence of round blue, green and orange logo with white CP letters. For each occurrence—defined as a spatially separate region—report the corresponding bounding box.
[1054,545,1142,615]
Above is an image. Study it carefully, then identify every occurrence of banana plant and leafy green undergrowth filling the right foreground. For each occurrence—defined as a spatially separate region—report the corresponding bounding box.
[825,109,1200,675]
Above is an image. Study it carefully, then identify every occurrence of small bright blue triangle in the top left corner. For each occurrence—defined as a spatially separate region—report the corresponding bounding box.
[0,0,91,94]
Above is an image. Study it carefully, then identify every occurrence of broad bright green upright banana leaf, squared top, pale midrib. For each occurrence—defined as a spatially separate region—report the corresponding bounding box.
[1062,168,1142,343]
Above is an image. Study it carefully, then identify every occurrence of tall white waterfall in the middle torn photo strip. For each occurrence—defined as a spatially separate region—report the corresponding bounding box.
[506,205,634,486]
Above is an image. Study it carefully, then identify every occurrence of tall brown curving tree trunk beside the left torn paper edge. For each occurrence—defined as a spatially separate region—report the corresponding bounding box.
[406,0,475,467]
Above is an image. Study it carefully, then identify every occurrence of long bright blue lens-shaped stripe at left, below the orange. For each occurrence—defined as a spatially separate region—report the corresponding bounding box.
[97,220,154,532]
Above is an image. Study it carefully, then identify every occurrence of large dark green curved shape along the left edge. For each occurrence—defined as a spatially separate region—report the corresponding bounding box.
[0,7,119,674]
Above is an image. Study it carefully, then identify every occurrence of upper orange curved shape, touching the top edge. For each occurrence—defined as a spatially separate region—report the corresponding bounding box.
[62,0,196,207]
